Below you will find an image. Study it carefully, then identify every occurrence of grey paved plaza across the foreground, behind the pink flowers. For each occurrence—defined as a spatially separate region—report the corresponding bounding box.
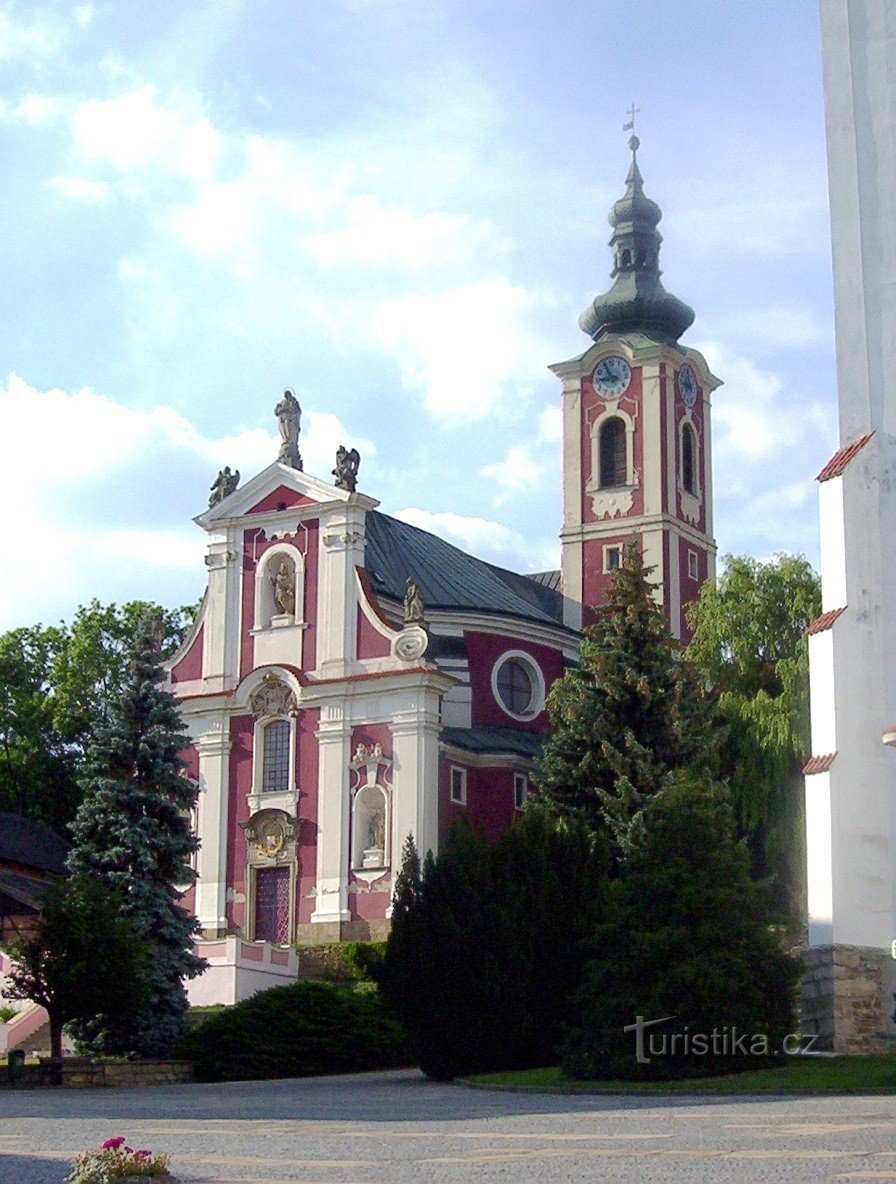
[0,1072,896,1184]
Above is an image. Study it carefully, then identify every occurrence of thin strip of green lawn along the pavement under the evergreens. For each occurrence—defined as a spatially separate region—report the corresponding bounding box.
[465,1054,896,1095]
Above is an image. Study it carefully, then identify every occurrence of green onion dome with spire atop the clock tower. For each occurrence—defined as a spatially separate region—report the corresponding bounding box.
[579,135,694,345]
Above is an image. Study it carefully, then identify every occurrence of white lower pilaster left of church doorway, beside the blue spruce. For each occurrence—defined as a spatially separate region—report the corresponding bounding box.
[195,714,231,938]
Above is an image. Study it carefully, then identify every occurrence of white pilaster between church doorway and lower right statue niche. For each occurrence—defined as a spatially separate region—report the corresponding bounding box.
[311,702,352,941]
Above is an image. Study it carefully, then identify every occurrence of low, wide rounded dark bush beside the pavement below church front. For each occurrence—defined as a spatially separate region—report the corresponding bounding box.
[178,980,410,1081]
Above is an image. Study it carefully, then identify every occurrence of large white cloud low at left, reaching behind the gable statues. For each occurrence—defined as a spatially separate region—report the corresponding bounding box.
[0,374,375,629]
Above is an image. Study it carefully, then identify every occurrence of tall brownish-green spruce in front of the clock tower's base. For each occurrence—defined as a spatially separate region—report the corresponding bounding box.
[537,541,713,855]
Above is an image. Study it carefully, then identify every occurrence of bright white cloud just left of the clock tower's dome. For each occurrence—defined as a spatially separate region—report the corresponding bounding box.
[359,277,546,419]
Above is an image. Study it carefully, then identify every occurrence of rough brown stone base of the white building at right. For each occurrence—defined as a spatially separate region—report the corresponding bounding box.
[800,946,896,1055]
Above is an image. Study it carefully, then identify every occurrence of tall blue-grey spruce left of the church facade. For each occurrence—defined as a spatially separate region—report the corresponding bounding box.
[69,617,205,1056]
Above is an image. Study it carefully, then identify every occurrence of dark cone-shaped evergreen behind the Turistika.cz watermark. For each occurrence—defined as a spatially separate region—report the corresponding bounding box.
[563,773,800,1080]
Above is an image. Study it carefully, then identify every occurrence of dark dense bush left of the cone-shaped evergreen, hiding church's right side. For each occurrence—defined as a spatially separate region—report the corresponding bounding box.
[382,806,606,1079]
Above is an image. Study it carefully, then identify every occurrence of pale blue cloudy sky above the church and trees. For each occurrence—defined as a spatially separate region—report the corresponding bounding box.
[0,0,837,628]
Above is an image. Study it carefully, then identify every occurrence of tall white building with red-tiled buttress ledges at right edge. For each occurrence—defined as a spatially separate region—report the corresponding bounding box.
[804,0,896,1053]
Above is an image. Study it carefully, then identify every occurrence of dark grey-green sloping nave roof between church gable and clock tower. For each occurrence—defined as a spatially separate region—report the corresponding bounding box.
[365,510,563,625]
